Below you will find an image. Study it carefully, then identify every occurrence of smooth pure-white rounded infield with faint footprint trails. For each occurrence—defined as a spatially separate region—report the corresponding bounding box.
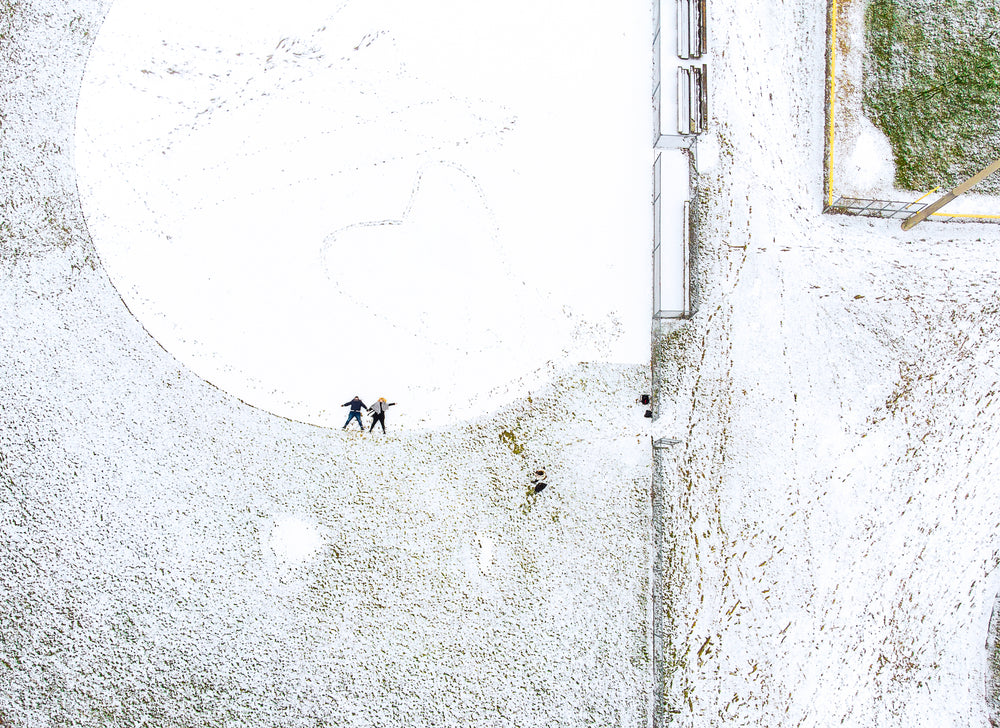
[77,0,649,427]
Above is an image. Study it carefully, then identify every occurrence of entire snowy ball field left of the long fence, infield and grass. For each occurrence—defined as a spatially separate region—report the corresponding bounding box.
[0,0,653,728]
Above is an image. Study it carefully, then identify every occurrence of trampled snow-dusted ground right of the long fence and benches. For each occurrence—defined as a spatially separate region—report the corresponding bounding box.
[654,2,1000,727]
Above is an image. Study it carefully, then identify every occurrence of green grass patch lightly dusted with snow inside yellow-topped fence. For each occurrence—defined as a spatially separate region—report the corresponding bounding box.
[863,0,1000,193]
